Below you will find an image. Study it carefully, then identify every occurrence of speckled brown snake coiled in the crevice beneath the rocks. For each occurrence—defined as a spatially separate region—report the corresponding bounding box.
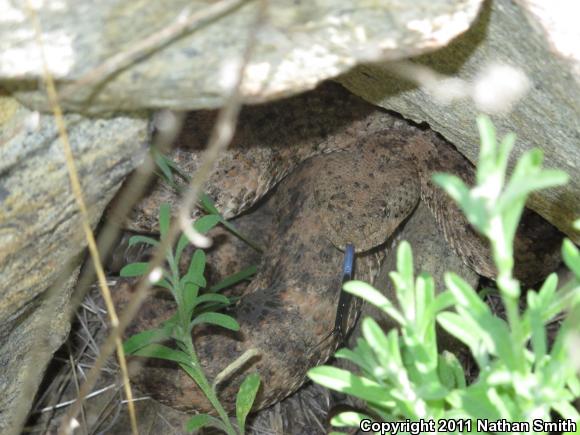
[110,84,558,411]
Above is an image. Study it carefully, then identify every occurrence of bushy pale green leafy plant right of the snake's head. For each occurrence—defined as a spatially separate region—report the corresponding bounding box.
[308,117,580,433]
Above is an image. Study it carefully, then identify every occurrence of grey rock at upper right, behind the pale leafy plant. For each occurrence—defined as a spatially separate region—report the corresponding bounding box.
[339,0,580,243]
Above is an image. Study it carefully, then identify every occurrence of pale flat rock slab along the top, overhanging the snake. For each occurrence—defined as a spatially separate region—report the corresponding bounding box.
[0,0,482,113]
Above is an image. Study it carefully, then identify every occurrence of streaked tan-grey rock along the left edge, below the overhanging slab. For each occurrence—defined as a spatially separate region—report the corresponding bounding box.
[0,94,147,433]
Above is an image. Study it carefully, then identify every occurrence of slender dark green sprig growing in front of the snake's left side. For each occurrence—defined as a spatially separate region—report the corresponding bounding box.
[121,204,260,435]
